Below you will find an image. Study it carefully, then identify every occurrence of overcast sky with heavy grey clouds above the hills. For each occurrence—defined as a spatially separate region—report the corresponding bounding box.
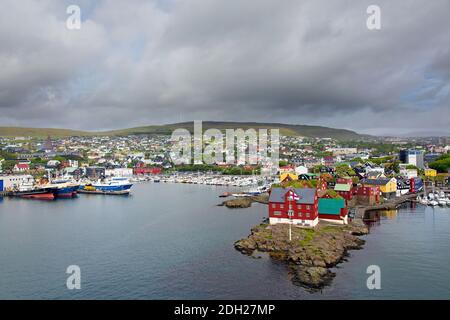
[0,0,450,135]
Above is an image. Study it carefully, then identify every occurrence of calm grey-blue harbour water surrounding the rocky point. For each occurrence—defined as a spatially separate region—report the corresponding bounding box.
[0,184,450,299]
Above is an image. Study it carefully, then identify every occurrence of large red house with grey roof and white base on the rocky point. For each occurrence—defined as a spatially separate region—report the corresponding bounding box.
[269,188,319,227]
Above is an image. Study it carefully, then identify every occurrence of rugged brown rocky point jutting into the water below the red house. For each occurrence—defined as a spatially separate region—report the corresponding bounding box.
[234,219,368,290]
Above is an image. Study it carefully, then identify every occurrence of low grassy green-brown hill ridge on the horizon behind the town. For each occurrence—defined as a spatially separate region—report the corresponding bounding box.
[0,121,367,140]
